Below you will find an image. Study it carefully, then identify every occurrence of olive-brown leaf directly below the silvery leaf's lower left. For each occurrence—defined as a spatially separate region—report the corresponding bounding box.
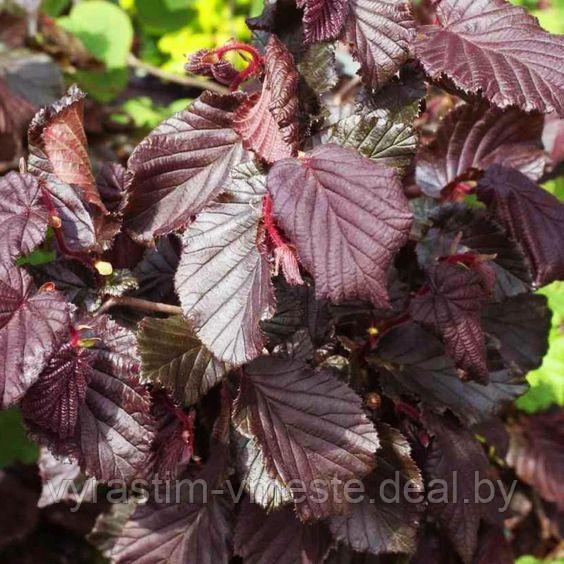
[138,316,226,404]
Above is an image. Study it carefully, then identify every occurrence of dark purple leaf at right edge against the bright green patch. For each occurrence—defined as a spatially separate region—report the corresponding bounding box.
[482,294,551,374]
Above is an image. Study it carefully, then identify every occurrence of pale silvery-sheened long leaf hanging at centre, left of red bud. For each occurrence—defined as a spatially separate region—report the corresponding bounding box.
[176,165,273,364]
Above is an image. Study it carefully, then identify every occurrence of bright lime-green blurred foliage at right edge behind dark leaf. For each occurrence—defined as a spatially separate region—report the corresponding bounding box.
[517,281,564,413]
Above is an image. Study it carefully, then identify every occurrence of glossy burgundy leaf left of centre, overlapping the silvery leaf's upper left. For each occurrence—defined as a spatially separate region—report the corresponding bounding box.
[126,92,249,242]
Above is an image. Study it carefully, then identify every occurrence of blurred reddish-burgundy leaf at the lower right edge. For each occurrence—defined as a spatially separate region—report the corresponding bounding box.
[507,407,564,510]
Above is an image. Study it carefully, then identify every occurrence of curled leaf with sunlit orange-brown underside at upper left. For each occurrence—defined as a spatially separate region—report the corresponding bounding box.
[28,86,106,212]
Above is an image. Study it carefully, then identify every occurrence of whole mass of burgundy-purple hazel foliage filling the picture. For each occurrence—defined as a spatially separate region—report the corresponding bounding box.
[0,0,564,563]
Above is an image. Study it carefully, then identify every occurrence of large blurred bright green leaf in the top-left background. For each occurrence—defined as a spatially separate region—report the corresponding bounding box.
[57,0,133,69]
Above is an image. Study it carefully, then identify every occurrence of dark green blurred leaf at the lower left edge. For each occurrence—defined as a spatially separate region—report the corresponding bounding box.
[0,408,39,468]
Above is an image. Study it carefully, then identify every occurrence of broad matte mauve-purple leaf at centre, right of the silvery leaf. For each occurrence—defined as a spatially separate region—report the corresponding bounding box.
[268,145,411,307]
